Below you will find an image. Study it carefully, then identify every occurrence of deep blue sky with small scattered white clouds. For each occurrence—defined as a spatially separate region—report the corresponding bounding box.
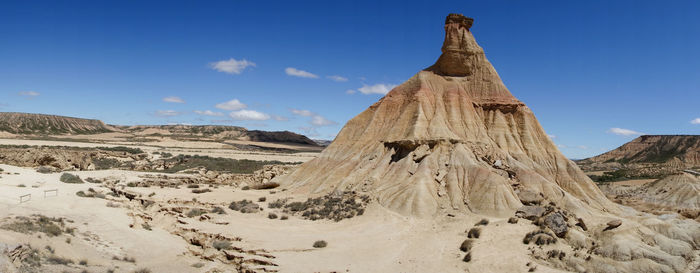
[0,1,700,158]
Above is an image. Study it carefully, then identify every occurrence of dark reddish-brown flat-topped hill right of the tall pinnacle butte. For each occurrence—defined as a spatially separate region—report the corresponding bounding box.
[578,135,700,166]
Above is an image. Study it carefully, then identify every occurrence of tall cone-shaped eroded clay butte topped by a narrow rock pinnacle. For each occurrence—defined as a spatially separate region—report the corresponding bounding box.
[281,14,614,216]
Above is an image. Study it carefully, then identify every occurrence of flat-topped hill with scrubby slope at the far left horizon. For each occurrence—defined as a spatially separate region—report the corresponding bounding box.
[0,113,115,135]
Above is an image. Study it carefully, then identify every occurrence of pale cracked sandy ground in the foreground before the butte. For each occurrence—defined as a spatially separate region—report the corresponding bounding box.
[0,165,560,272]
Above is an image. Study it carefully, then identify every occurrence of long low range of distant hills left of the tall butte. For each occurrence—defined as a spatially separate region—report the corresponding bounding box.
[0,113,318,146]
